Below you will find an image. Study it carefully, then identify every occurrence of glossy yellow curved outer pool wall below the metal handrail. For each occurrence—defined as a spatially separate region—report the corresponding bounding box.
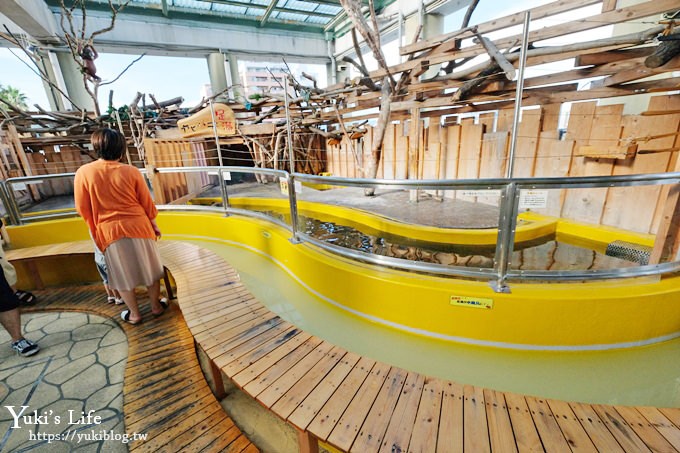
[10,212,680,350]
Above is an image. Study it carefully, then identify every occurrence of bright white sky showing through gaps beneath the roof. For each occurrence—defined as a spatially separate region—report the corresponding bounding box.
[0,0,636,110]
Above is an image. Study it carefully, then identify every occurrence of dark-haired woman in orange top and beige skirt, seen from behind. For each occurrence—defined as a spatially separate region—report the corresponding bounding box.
[74,129,168,324]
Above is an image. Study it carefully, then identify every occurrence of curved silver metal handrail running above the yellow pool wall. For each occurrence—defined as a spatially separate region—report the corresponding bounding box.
[0,166,680,292]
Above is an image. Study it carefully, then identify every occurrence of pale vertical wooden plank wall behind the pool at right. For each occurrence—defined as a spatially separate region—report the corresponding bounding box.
[328,95,680,234]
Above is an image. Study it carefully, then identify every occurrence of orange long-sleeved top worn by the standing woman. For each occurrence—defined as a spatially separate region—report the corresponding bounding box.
[73,159,158,251]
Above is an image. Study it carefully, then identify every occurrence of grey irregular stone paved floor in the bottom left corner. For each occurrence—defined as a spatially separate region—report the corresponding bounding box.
[0,312,128,453]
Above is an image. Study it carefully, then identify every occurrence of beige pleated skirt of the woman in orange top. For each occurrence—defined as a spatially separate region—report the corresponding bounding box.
[104,238,163,291]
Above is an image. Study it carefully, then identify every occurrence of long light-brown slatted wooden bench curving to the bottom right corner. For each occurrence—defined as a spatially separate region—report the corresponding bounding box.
[12,241,680,453]
